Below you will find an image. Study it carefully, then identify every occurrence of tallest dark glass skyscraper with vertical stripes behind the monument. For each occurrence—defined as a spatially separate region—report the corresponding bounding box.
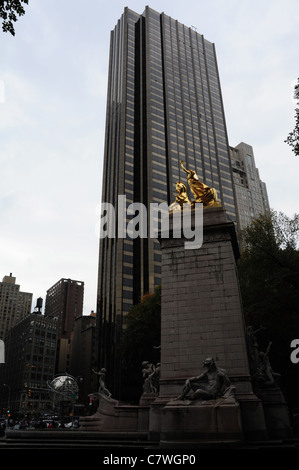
[97,7,236,396]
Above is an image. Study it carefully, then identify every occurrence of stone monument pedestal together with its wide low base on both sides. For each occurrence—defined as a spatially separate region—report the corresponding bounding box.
[80,205,290,448]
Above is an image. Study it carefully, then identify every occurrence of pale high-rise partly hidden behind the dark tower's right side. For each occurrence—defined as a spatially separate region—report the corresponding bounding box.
[230,142,270,231]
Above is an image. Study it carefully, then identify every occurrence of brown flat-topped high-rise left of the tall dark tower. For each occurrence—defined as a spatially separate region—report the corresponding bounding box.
[45,279,84,374]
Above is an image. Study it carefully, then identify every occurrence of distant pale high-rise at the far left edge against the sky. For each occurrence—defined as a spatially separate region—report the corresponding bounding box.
[0,274,32,339]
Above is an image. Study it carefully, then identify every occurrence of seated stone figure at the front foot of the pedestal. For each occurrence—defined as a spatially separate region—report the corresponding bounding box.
[178,357,235,400]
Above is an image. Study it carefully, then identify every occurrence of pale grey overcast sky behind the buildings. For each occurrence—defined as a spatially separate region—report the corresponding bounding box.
[0,0,299,314]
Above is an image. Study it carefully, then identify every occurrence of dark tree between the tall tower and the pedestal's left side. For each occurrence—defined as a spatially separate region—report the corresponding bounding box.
[121,287,161,400]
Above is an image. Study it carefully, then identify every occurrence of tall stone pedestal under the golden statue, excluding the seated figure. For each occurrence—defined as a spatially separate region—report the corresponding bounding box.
[149,207,267,445]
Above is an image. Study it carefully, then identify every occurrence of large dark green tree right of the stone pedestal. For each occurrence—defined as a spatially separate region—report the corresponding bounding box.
[238,211,299,406]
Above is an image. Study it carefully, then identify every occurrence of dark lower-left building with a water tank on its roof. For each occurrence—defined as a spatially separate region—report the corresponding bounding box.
[0,313,57,415]
